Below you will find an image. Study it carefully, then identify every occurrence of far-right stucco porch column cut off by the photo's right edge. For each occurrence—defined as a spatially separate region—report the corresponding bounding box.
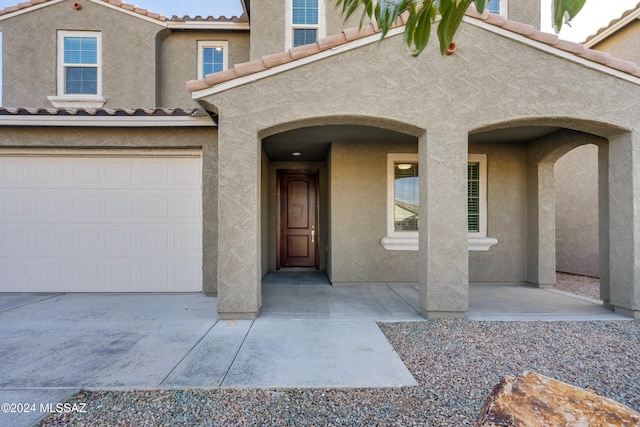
[609,132,640,319]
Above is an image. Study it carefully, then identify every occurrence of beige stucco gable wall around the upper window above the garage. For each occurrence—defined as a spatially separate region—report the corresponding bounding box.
[0,0,161,108]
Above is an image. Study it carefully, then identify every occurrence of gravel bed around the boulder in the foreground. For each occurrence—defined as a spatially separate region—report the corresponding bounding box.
[40,320,640,426]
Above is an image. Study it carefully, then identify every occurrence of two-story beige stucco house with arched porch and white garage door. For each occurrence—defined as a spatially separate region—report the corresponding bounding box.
[0,0,640,319]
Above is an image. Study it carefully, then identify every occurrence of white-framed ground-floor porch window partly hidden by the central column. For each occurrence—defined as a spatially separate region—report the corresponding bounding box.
[381,153,498,251]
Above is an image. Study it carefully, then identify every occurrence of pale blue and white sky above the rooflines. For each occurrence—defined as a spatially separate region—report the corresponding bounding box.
[0,0,640,105]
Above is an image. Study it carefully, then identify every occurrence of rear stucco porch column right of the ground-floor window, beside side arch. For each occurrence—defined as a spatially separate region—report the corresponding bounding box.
[527,156,556,288]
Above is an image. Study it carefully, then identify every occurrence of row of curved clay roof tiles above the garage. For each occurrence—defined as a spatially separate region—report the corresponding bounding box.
[0,107,200,117]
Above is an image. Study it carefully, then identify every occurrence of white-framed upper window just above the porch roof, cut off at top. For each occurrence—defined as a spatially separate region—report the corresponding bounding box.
[285,0,325,49]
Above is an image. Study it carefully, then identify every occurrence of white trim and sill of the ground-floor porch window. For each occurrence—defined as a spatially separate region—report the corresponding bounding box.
[380,153,498,251]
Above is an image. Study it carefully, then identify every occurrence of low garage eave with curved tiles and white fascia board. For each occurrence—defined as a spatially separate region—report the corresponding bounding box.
[0,107,215,127]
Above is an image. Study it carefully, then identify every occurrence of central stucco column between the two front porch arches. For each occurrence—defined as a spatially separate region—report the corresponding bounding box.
[418,128,469,319]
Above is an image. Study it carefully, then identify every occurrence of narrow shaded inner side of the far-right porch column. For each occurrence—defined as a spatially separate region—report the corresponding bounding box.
[598,142,611,306]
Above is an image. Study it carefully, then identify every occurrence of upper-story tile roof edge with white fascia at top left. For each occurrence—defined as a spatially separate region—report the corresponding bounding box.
[0,0,249,30]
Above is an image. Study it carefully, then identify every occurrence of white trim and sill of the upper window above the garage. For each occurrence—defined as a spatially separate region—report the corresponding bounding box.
[47,30,106,108]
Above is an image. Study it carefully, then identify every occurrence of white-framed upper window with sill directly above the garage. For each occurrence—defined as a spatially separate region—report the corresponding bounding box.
[48,31,105,108]
